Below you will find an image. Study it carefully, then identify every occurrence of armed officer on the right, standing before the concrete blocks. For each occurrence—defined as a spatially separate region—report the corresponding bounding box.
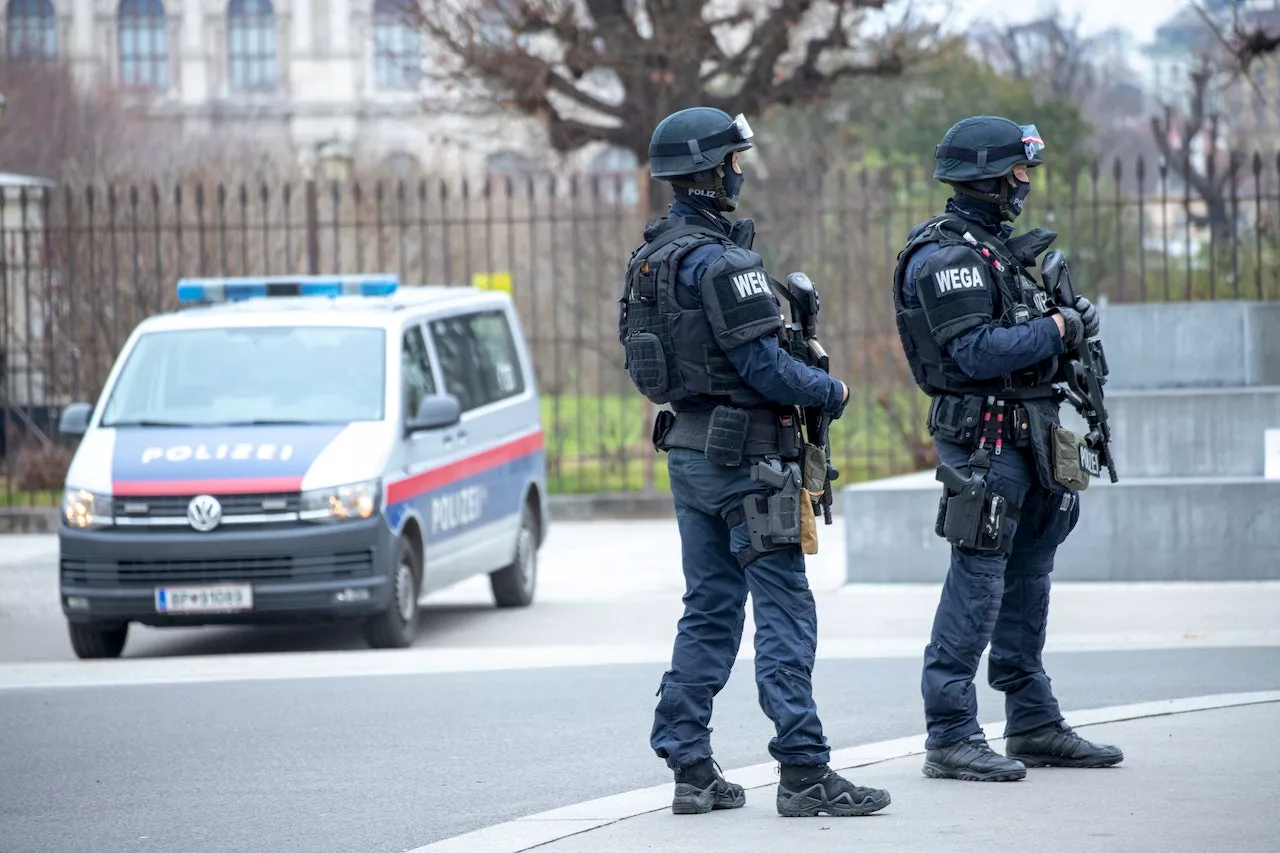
[893,115,1124,781]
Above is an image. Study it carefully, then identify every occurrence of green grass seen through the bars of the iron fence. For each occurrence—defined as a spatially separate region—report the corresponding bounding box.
[0,389,931,508]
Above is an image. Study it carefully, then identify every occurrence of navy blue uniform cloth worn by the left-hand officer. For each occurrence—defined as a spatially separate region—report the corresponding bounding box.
[650,202,844,770]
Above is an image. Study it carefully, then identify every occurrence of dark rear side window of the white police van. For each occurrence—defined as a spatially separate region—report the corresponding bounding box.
[431,311,525,411]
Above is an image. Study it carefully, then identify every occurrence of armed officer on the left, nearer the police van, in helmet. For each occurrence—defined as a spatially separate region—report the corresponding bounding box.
[618,108,890,816]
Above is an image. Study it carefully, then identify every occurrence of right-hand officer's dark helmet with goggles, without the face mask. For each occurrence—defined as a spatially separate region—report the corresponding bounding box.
[933,115,1044,183]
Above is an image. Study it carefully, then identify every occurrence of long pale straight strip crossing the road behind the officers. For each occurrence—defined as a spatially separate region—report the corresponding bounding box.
[0,629,1280,690]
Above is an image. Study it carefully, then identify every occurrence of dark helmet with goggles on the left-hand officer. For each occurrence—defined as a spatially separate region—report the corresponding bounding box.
[649,106,751,179]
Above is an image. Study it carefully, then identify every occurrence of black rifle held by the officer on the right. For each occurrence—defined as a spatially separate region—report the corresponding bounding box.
[1041,248,1119,483]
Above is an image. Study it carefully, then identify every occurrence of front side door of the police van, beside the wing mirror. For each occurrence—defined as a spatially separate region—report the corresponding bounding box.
[387,321,460,592]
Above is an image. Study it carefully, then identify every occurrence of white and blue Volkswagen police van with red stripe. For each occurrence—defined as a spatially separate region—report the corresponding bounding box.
[59,277,548,657]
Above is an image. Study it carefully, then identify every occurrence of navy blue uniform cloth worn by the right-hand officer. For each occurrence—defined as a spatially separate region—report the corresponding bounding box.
[902,202,1079,749]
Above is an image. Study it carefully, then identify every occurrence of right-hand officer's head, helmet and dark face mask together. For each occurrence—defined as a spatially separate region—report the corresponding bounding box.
[933,115,1044,222]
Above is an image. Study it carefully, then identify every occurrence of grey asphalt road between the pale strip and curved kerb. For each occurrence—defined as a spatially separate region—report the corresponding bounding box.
[0,647,1280,853]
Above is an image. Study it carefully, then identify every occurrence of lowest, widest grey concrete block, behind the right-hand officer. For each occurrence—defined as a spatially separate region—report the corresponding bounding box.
[841,471,1280,583]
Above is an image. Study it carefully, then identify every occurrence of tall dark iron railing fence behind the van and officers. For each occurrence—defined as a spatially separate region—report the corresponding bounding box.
[0,155,1280,508]
